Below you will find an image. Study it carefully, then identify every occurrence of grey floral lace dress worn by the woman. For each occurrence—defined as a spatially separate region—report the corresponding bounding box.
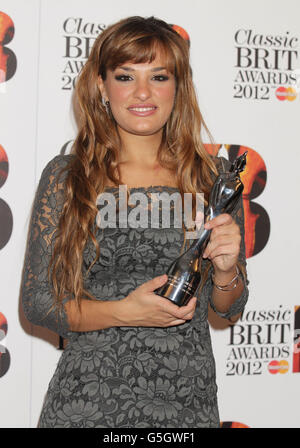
[21,155,248,428]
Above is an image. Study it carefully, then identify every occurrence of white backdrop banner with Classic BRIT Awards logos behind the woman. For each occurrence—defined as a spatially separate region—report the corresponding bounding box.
[0,0,300,428]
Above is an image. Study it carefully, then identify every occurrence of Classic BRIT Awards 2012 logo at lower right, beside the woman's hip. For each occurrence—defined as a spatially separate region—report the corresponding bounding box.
[226,305,300,376]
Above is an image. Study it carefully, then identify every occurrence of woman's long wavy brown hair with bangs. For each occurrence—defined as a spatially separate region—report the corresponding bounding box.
[49,17,217,307]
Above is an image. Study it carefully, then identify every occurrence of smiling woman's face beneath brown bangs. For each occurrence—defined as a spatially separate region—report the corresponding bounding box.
[99,51,176,136]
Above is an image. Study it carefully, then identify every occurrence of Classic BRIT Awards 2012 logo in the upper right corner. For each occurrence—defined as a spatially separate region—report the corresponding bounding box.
[233,28,299,102]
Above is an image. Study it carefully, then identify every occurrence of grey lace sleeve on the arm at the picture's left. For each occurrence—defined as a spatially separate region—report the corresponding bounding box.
[21,156,71,337]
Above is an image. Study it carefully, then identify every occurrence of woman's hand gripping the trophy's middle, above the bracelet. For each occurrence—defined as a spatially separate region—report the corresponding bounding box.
[203,213,241,274]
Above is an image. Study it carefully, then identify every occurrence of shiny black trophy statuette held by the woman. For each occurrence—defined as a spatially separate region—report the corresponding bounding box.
[154,152,247,306]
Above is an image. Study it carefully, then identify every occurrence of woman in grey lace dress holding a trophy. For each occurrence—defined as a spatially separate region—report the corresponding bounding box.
[22,17,248,427]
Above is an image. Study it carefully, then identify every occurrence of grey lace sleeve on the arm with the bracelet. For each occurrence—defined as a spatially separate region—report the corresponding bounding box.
[203,157,249,319]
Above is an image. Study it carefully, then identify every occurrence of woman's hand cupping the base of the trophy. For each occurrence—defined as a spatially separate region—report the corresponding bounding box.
[118,274,197,327]
